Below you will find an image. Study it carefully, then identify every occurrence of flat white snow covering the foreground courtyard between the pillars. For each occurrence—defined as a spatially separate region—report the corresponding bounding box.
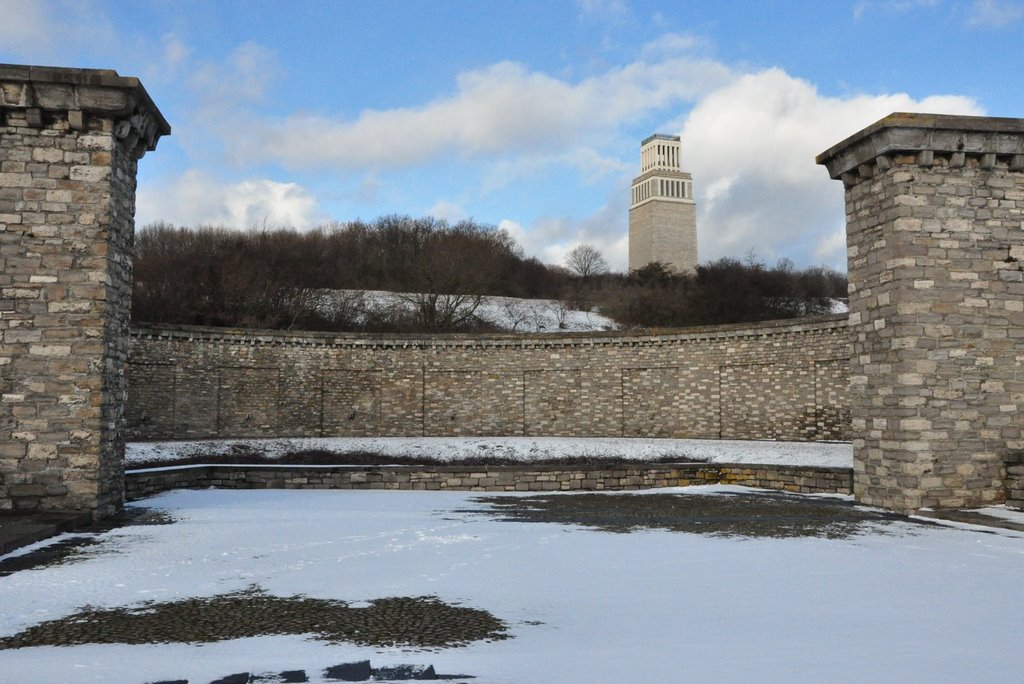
[0,486,1024,684]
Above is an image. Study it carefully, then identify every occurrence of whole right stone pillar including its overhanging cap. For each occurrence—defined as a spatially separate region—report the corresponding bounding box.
[817,114,1024,512]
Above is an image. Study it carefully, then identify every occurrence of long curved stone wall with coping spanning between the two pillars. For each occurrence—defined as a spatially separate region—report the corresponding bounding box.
[128,316,850,440]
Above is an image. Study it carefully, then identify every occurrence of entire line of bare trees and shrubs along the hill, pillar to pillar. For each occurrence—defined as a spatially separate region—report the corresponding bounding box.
[132,215,846,332]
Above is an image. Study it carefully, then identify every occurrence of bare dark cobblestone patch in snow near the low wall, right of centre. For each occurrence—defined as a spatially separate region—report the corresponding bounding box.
[460,494,907,539]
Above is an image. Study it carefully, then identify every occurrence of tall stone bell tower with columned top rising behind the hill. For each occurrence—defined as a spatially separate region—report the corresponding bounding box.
[630,133,697,273]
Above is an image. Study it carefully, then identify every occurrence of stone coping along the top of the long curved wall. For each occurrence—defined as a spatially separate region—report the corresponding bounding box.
[131,313,848,348]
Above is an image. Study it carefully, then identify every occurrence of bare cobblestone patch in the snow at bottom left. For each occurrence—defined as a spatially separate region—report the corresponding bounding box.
[0,588,509,649]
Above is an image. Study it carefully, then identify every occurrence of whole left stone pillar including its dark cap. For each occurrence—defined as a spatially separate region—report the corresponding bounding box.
[0,65,170,518]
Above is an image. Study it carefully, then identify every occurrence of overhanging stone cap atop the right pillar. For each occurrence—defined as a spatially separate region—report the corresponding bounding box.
[814,112,1024,178]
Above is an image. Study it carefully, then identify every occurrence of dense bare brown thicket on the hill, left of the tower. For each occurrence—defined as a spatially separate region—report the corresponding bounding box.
[132,216,568,332]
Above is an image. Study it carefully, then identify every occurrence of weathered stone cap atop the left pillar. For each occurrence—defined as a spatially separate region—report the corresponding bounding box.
[0,65,171,149]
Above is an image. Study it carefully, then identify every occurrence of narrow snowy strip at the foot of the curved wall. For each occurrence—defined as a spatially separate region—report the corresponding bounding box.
[125,437,853,468]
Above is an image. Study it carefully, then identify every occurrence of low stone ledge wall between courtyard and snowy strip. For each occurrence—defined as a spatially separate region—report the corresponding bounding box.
[125,463,853,500]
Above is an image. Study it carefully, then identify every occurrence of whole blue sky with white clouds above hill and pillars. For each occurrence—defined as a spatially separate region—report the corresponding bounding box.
[0,0,1024,269]
